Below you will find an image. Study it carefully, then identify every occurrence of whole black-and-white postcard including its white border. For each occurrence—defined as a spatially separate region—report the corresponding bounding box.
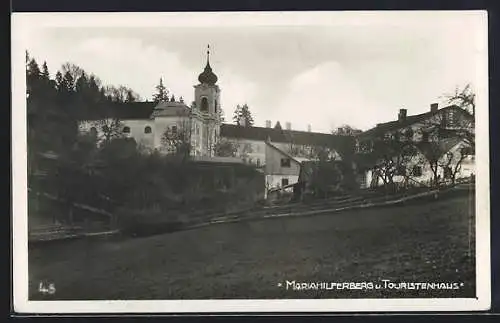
[12,11,491,313]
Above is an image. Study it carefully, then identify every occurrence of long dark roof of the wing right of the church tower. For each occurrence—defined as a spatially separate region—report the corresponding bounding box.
[221,123,354,154]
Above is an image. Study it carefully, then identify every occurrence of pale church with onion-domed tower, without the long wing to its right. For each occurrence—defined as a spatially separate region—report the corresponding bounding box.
[80,47,221,157]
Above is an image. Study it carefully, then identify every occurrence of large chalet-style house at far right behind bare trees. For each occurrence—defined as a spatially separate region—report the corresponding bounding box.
[356,103,475,188]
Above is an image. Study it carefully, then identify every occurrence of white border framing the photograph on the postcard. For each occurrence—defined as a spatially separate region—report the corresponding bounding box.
[11,11,491,314]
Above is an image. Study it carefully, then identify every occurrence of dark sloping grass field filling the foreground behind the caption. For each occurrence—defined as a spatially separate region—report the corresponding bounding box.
[29,192,475,300]
